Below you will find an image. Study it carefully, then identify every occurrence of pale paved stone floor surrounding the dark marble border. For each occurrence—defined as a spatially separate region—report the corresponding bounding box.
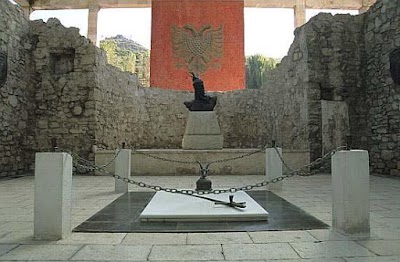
[0,174,400,262]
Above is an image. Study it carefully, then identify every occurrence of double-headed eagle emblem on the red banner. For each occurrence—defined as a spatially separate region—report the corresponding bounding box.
[172,24,224,75]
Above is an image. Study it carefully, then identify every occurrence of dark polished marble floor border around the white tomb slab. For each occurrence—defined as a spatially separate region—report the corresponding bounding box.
[74,190,329,233]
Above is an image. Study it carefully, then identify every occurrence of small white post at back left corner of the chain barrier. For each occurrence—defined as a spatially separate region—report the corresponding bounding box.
[115,149,132,193]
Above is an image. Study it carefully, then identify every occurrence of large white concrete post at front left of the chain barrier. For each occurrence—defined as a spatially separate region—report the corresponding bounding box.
[33,153,72,240]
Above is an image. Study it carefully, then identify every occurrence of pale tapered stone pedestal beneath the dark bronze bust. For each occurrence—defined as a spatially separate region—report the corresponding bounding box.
[182,111,224,150]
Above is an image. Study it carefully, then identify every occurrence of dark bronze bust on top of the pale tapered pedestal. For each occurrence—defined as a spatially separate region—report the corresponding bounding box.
[184,73,217,111]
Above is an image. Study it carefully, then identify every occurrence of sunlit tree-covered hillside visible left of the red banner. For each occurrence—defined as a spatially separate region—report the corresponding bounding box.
[100,35,150,86]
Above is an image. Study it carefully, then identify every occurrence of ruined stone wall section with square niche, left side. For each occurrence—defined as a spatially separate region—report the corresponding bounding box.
[29,19,99,162]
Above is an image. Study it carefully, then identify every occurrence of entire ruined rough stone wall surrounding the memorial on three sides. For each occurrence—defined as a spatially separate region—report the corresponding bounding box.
[0,0,400,176]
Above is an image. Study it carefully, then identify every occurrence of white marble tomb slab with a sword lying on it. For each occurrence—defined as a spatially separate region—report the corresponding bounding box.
[140,191,268,222]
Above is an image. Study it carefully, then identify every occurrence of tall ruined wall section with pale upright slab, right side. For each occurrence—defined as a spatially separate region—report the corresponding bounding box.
[303,14,366,159]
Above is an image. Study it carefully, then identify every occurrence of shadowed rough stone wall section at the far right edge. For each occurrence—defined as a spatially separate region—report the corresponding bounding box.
[362,0,400,176]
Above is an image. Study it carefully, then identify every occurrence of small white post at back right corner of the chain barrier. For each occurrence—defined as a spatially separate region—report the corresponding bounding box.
[265,147,282,191]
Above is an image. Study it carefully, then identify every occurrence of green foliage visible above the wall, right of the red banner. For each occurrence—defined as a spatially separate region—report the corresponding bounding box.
[246,54,279,89]
